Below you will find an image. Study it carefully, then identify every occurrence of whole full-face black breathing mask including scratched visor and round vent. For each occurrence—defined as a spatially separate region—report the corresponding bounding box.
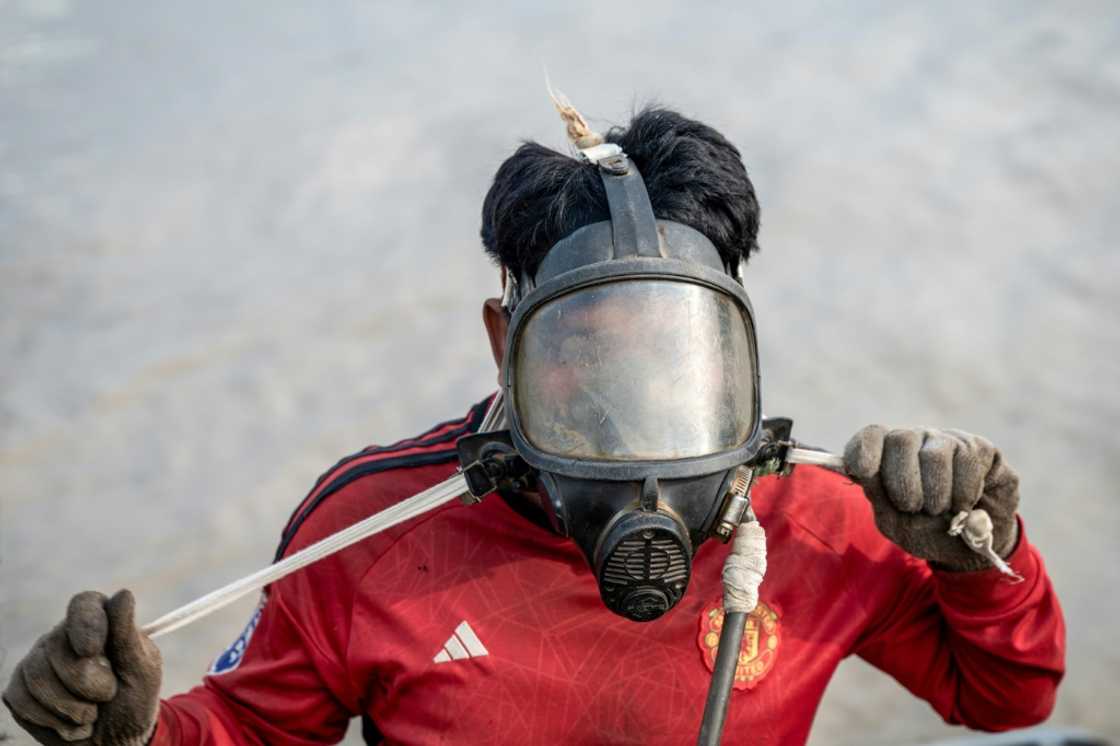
[502,143,760,622]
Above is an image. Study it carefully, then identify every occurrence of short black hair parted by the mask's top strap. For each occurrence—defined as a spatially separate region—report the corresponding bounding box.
[482,108,758,276]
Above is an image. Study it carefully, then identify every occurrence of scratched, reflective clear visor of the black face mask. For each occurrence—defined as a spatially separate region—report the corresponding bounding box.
[513,279,755,461]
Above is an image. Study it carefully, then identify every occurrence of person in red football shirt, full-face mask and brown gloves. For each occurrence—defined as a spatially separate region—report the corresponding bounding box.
[3,100,1065,746]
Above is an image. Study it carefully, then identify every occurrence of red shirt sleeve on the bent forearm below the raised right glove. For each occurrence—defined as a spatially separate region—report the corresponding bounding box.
[855,521,1065,730]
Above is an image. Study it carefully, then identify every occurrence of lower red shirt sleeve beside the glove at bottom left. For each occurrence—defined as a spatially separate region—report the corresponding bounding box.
[151,586,352,746]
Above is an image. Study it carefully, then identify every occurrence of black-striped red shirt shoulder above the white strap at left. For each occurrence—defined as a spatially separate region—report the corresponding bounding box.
[276,398,491,560]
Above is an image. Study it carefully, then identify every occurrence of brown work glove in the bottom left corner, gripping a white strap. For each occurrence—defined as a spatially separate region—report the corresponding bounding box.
[3,590,162,746]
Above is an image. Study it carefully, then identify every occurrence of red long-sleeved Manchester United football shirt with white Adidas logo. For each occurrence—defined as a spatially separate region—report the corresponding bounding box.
[152,398,1065,745]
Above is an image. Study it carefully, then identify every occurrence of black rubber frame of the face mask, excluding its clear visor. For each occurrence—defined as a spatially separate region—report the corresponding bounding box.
[501,146,763,621]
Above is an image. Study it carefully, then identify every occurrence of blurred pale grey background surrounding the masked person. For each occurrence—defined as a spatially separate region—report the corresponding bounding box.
[0,0,1120,746]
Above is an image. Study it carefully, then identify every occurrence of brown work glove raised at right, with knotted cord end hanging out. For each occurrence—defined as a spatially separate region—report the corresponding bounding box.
[843,425,1019,570]
